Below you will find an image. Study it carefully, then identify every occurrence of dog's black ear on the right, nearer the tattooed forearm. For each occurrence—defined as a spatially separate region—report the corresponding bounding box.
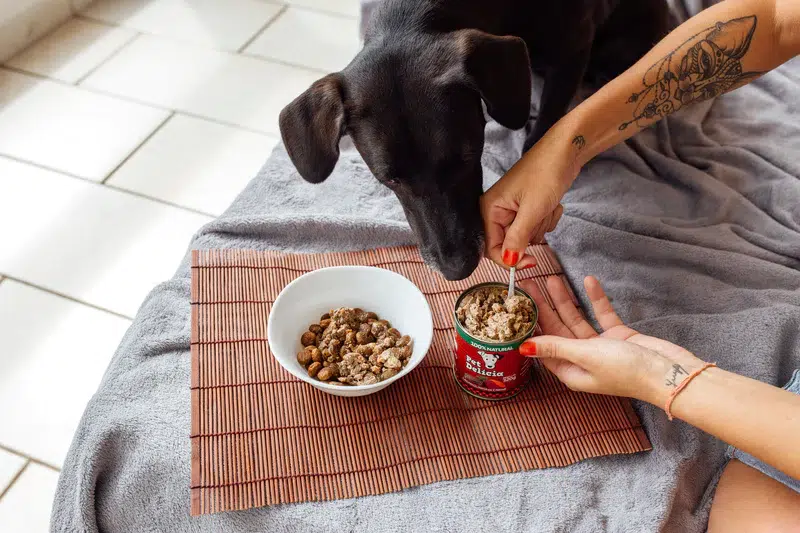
[456,30,531,130]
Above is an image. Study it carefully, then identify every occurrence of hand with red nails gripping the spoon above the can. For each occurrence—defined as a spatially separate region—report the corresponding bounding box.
[481,130,580,269]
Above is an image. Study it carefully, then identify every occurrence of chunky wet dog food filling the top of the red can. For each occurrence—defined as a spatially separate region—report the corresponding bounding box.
[456,287,534,341]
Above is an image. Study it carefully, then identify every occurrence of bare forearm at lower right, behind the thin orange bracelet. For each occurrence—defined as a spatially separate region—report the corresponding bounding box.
[648,368,800,479]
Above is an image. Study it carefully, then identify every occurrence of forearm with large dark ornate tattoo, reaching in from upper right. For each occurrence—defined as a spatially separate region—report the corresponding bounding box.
[550,0,800,166]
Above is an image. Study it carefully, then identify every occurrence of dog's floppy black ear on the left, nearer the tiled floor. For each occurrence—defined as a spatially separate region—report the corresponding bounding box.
[278,74,344,183]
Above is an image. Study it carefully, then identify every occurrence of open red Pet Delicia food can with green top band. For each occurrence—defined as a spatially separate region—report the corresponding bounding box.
[453,283,539,400]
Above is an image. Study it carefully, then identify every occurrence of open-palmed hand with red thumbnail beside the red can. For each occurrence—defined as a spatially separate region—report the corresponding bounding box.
[519,276,703,406]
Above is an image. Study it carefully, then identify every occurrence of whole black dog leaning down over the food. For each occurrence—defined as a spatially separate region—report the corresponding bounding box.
[280,0,672,280]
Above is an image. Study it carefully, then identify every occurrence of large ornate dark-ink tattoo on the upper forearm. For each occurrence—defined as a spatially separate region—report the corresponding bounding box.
[620,15,763,131]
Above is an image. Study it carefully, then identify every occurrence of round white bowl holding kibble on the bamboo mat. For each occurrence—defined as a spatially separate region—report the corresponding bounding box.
[267,266,433,396]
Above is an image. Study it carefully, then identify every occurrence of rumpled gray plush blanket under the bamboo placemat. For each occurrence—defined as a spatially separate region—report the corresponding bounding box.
[52,7,800,533]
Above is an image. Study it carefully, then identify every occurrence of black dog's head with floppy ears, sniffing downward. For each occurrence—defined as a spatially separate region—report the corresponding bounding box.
[280,30,531,280]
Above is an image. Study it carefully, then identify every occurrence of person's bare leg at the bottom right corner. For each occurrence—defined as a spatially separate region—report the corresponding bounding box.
[708,460,800,533]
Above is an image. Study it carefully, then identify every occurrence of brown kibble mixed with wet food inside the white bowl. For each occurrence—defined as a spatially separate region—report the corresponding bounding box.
[297,307,413,385]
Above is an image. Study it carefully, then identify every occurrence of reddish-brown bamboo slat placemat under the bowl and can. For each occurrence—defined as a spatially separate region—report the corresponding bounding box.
[191,245,650,515]
